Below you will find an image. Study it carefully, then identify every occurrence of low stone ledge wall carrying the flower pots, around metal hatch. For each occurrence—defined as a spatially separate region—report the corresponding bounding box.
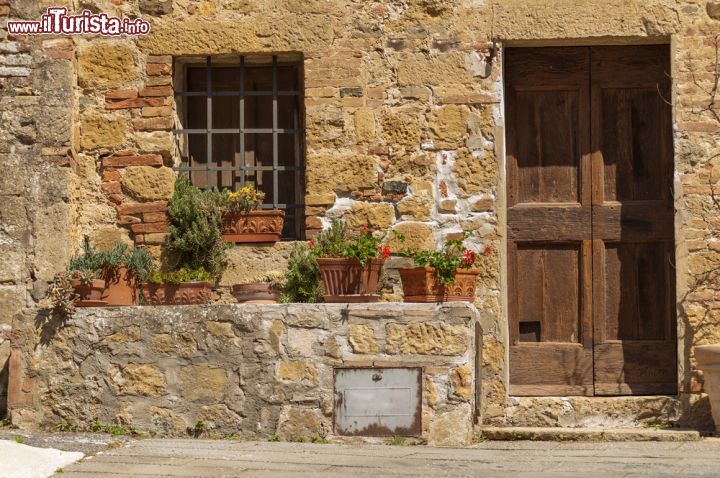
[13,304,477,445]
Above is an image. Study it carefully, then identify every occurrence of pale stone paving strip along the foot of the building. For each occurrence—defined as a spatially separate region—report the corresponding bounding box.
[56,438,720,478]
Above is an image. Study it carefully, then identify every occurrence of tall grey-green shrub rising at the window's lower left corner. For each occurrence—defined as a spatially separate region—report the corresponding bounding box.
[165,174,227,280]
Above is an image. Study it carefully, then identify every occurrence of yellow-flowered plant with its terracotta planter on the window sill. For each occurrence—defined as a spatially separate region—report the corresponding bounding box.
[222,185,285,243]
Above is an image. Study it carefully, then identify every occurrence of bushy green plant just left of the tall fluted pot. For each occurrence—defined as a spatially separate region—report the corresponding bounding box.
[280,244,322,303]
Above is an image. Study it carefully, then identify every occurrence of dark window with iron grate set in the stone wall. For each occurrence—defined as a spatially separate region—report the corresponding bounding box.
[172,55,305,239]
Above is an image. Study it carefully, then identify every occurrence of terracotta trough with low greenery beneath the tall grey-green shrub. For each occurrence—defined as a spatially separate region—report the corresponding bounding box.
[142,268,213,305]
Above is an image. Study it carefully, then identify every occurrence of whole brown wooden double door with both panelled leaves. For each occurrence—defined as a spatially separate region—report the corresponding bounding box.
[505,46,677,395]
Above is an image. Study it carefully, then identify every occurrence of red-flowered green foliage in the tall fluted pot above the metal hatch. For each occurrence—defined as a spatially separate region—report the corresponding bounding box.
[310,219,390,265]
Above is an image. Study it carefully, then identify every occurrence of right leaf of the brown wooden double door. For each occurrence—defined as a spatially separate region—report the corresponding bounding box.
[590,45,677,395]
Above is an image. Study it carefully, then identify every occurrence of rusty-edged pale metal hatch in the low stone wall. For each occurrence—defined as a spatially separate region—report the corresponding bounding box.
[334,367,422,436]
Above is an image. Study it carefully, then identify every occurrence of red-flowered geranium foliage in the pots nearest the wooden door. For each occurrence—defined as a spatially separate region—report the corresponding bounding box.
[398,233,492,286]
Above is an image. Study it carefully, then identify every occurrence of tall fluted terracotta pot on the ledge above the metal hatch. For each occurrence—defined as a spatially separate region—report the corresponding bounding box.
[317,258,385,302]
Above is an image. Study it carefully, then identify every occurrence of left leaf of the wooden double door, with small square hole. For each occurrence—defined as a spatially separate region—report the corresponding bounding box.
[505,48,593,395]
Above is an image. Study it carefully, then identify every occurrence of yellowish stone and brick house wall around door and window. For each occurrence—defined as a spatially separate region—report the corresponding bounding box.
[0,0,720,436]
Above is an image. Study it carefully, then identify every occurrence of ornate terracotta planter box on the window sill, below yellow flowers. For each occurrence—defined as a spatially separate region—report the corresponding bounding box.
[222,209,285,242]
